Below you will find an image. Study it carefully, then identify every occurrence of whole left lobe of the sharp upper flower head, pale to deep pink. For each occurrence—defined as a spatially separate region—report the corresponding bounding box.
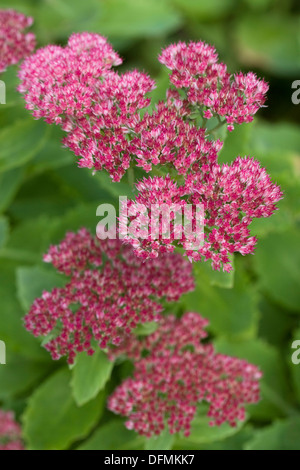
[19,33,154,181]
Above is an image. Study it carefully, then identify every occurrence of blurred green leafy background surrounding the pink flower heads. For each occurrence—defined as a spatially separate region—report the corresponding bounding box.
[0,0,300,450]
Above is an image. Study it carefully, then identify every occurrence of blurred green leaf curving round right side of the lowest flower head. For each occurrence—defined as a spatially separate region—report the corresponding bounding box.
[215,339,293,421]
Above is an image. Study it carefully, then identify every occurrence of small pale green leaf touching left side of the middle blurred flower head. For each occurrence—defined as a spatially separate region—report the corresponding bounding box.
[17,266,66,312]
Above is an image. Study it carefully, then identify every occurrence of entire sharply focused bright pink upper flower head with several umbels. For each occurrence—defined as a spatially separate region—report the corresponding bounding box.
[19,33,282,271]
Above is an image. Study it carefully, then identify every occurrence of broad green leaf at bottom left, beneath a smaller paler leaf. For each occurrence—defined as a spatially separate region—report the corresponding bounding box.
[23,368,104,450]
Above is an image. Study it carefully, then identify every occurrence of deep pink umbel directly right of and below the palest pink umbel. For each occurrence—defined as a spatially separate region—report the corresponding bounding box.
[64,71,154,181]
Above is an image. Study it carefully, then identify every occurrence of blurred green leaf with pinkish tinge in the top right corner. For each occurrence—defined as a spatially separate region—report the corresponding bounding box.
[234,13,300,76]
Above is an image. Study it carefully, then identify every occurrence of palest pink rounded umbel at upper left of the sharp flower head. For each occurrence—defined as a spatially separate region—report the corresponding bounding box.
[19,33,122,124]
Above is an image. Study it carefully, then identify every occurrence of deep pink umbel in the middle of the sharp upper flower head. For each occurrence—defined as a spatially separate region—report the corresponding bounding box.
[130,90,222,175]
